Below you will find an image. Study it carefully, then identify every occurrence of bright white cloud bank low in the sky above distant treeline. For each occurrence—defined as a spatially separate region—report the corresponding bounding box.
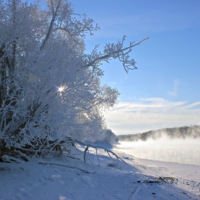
[105,98,200,134]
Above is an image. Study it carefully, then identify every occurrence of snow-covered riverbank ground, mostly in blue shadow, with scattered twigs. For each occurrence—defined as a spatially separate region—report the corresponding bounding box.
[0,145,200,200]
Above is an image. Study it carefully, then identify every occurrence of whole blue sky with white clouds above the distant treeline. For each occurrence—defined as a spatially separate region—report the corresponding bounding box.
[72,0,200,134]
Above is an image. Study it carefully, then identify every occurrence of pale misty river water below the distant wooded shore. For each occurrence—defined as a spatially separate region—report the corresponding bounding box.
[116,136,200,166]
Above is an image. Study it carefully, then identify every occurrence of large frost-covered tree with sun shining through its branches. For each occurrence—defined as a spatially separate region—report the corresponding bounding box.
[0,0,147,159]
